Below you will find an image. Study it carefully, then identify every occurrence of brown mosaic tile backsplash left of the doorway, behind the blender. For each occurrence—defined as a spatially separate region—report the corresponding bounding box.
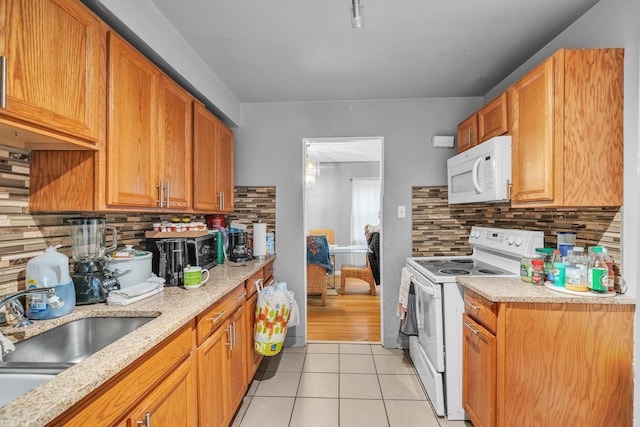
[0,146,276,295]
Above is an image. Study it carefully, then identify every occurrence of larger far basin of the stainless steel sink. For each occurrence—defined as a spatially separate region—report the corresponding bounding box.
[0,317,154,372]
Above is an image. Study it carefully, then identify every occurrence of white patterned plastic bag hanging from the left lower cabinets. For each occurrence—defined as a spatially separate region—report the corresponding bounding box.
[254,282,299,356]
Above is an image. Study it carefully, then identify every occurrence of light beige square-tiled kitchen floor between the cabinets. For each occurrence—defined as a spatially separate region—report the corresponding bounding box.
[232,343,472,427]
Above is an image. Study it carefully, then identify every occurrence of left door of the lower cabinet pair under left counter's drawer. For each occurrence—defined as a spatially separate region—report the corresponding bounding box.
[196,325,231,427]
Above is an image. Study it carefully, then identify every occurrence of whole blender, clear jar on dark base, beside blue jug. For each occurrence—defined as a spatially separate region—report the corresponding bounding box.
[68,218,120,305]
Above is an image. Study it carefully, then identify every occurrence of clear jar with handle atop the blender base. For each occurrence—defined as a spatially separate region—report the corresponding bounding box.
[68,218,118,263]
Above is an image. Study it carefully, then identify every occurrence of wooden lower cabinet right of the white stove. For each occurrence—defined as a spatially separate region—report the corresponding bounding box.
[462,289,634,427]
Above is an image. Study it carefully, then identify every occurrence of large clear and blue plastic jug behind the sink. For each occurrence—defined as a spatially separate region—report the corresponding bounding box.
[25,246,76,320]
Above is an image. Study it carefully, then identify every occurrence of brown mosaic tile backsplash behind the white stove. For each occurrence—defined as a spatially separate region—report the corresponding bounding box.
[411,190,622,287]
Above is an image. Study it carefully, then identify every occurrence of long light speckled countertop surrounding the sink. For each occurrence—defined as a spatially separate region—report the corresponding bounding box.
[0,257,274,427]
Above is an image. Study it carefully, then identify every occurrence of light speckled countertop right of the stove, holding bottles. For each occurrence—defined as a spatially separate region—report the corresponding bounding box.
[456,276,636,305]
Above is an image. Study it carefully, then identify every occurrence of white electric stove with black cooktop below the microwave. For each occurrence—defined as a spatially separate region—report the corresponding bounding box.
[406,227,544,420]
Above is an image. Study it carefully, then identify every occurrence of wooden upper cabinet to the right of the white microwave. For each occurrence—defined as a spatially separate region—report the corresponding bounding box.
[509,49,624,207]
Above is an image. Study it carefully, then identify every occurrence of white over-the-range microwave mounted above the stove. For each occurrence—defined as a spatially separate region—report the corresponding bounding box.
[447,136,511,204]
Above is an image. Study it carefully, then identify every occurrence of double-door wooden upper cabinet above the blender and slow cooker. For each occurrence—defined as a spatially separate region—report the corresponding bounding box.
[106,32,193,211]
